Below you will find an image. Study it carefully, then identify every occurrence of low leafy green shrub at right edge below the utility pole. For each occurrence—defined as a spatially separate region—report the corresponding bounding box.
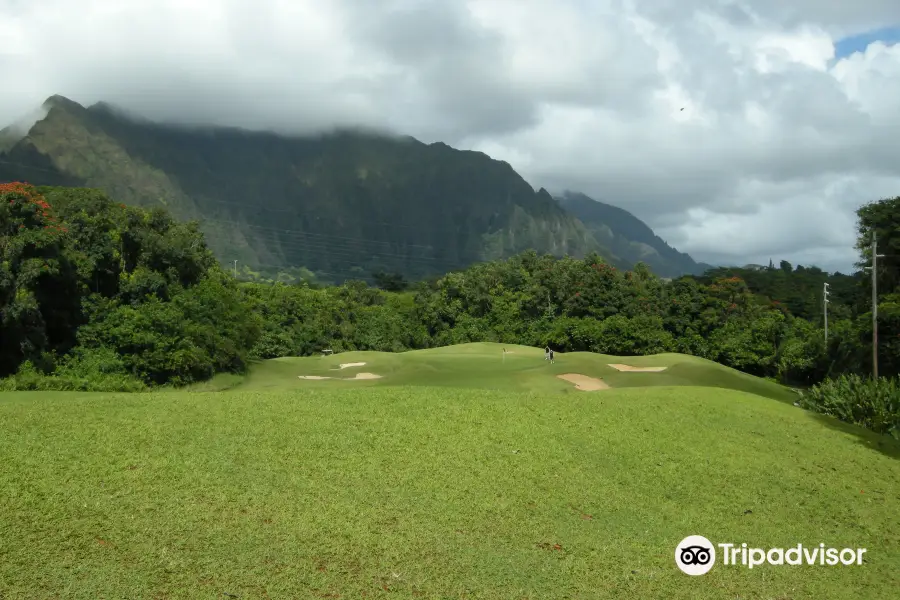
[800,375,900,439]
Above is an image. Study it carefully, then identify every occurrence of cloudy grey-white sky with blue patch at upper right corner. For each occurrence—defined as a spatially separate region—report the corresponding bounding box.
[0,0,900,272]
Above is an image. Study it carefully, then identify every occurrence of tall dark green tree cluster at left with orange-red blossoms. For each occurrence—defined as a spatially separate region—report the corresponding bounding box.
[0,184,260,384]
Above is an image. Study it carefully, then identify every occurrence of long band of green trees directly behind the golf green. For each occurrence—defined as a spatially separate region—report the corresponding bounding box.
[220,252,828,384]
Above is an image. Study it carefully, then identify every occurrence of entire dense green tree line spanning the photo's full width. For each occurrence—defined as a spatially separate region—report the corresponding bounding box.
[0,183,900,436]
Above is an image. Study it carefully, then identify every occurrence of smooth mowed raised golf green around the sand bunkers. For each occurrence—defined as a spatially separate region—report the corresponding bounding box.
[229,343,797,402]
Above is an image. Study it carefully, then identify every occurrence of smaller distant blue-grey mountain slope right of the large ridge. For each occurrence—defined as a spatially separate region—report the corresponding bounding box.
[556,192,713,277]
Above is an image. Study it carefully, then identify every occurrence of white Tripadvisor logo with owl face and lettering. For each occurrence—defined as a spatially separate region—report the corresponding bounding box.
[675,535,866,575]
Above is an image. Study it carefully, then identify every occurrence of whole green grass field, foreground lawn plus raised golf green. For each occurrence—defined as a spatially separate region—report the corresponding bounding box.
[0,344,900,600]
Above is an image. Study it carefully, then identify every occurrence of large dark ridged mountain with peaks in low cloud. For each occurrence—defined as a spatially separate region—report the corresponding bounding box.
[0,96,694,282]
